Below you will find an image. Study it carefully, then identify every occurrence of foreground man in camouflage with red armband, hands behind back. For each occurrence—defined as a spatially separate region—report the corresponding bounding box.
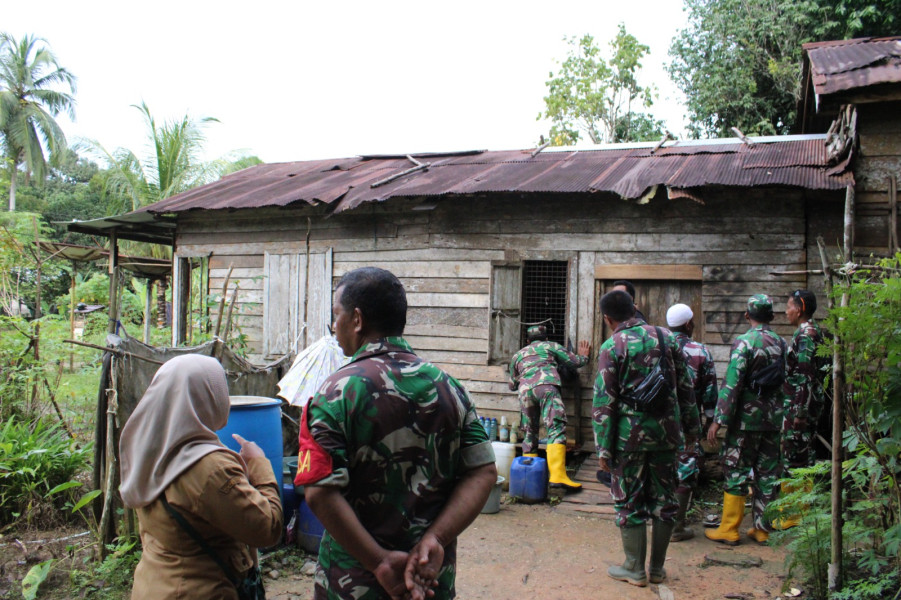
[295,267,497,600]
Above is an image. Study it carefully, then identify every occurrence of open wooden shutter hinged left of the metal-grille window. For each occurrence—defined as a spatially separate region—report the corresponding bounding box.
[488,262,522,365]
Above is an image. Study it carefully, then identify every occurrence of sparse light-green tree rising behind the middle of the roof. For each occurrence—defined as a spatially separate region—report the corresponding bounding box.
[538,23,662,146]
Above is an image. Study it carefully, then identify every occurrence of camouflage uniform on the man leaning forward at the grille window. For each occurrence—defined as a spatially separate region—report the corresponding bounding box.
[510,340,588,454]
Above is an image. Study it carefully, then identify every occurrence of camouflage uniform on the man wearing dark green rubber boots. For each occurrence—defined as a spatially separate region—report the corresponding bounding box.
[592,318,700,528]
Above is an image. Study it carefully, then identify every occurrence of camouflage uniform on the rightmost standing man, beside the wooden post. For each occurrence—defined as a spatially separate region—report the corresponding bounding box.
[782,320,825,469]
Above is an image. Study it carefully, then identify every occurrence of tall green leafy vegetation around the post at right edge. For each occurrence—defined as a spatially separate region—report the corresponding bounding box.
[773,254,901,599]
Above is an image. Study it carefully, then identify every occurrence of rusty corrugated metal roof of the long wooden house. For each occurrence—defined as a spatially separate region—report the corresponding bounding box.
[135,135,853,214]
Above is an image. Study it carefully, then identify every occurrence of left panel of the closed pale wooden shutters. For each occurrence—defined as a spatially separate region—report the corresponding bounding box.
[263,252,300,357]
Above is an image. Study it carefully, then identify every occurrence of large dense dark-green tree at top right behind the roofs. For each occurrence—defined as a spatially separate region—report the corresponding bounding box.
[668,0,901,137]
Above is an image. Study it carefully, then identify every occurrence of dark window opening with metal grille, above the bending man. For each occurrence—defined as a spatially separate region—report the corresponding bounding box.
[520,260,568,347]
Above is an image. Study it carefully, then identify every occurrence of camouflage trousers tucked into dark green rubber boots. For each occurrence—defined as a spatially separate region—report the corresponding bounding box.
[610,450,679,527]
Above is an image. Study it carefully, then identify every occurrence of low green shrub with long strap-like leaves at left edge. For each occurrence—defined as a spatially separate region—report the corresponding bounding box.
[0,418,91,526]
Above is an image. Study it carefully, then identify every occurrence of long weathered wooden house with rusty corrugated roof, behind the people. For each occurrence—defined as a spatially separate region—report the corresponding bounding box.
[73,134,854,448]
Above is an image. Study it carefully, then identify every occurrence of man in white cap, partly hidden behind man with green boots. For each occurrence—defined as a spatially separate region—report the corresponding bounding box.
[666,304,717,542]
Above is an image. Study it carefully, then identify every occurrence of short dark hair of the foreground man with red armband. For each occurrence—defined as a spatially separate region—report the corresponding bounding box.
[337,267,407,336]
